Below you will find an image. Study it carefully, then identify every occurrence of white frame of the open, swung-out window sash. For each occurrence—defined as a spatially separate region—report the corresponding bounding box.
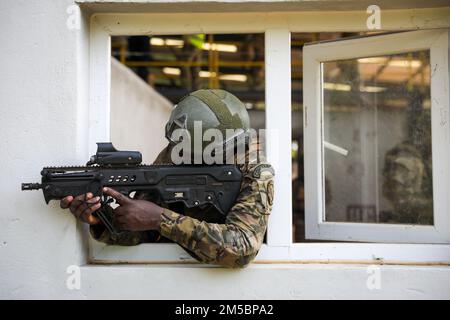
[303,29,450,243]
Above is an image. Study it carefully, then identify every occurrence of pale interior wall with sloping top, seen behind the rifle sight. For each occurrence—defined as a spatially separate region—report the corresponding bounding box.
[110,59,173,163]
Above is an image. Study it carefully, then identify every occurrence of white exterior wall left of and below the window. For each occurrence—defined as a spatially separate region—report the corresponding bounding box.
[0,0,450,299]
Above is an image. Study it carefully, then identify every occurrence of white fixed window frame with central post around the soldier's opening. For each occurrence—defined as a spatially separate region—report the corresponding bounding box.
[86,11,450,264]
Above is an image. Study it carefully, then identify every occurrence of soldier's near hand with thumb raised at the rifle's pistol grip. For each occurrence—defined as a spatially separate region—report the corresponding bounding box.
[103,188,164,231]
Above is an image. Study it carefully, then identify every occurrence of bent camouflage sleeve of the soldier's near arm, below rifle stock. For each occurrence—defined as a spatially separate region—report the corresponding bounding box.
[159,164,274,267]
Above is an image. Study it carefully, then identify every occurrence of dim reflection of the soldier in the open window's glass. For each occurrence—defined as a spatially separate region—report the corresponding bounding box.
[383,110,433,225]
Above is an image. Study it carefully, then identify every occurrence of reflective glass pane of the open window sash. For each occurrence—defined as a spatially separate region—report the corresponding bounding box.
[322,51,433,225]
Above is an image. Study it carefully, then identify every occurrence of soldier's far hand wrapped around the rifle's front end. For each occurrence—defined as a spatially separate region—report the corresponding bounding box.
[59,193,101,225]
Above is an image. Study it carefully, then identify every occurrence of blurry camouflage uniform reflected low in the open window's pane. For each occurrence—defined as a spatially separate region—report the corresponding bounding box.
[383,143,433,224]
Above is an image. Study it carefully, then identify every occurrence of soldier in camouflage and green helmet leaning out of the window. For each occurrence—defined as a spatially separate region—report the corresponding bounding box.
[56,90,274,267]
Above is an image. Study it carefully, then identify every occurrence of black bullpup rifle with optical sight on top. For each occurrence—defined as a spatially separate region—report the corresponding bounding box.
[22,142,242,238]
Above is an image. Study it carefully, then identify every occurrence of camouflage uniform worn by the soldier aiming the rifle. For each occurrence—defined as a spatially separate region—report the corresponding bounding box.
[91,143,274,267]
